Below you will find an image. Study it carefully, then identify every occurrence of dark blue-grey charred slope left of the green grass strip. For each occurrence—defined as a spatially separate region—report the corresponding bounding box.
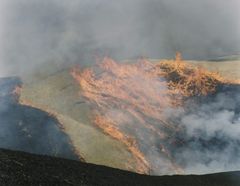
[0,77,78,159]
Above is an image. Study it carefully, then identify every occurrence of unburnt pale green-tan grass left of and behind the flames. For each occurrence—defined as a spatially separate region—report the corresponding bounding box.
[20,57,240,173]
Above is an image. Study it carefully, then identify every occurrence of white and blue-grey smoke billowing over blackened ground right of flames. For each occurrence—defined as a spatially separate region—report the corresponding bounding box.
[168,86,240,174]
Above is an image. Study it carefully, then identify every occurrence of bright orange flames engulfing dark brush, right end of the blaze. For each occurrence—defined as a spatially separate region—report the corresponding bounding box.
[157,53,226,98]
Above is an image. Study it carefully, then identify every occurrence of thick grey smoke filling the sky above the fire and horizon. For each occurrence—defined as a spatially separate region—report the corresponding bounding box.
[0,0,240,74]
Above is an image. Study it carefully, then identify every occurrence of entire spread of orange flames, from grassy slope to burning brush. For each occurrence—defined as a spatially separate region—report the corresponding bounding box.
[71,53,234,173]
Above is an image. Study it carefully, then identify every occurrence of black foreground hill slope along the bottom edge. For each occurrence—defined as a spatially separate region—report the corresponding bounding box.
[0,149,240,186]
